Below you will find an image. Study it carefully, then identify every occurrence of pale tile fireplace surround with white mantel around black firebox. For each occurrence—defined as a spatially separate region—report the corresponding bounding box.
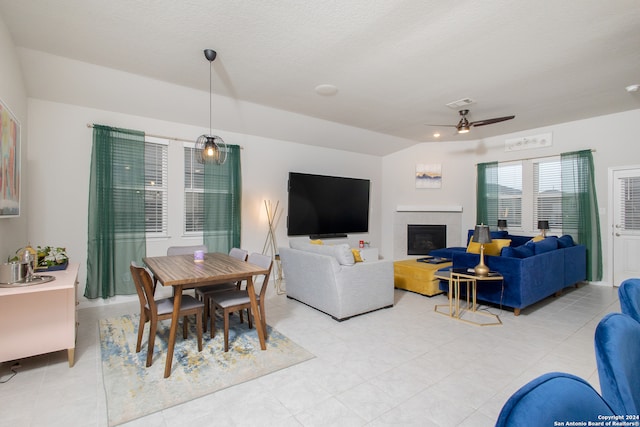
[393,206,462,259]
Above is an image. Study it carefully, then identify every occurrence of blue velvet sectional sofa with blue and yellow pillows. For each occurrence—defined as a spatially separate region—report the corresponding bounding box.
[430,231,587,316]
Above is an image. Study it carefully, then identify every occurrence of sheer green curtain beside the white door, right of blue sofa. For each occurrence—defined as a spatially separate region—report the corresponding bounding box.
[561,150,602,281]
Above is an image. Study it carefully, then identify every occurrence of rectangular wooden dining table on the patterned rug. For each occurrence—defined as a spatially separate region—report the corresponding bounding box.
[142,252,268,378]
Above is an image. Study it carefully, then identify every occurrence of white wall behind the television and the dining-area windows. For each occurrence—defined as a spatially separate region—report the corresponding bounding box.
[28,99,382,306]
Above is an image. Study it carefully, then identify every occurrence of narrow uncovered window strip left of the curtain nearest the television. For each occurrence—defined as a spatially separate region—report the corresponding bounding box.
[184,145,204,234]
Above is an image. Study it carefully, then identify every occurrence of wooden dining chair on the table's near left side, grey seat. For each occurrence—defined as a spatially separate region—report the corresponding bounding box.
[129,262,204,367]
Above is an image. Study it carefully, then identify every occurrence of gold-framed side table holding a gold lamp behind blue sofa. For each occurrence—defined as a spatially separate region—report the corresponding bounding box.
[434,268,504,326]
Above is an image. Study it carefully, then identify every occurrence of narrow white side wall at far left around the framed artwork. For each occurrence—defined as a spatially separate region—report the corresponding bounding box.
[0,16,29,262]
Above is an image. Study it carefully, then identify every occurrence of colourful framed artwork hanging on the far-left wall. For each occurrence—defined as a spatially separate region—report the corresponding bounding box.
[0,100,20,218]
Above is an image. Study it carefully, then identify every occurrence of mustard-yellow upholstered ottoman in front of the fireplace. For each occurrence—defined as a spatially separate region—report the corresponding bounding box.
[393,259,451,297]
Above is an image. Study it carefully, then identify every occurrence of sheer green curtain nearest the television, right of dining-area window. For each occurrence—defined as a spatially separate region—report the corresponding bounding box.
[203,145,242,253]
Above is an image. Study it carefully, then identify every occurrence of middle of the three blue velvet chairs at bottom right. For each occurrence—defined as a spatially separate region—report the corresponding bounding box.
[595,313,640,414]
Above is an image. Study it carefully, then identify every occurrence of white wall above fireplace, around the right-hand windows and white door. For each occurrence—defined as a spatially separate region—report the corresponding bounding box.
[382,109,640,286]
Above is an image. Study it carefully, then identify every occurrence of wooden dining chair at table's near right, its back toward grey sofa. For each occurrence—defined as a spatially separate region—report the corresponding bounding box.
[209,253,273,352]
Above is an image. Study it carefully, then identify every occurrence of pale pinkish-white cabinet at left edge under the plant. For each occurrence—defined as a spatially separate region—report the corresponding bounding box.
[0,263,79,367]
